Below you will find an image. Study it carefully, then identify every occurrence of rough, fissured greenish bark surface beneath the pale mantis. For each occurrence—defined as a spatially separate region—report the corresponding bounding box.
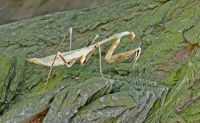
[0,0,200,123]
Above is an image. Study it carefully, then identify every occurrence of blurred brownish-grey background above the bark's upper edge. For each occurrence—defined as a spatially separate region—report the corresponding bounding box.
[0,0,117,24]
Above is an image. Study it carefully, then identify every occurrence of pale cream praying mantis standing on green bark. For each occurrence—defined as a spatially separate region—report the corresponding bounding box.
[27,28,141,86]
